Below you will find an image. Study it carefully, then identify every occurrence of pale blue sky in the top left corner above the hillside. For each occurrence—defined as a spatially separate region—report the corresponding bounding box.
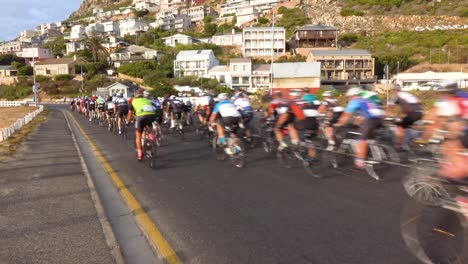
[0,0,83,41]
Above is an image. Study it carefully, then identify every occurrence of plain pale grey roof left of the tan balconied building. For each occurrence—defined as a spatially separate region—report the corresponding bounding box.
[273,62,320,78]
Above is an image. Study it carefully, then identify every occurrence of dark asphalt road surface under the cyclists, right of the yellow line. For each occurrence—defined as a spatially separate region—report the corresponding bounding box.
[60,104,458,264]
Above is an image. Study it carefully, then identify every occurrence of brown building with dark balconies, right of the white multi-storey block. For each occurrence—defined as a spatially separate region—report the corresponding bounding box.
[289,25,338,56]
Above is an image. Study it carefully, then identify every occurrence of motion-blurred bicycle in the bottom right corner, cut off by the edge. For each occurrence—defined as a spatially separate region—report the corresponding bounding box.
[400,159,468,263]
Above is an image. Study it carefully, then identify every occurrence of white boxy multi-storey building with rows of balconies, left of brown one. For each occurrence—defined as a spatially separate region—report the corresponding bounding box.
[242,27,286,58]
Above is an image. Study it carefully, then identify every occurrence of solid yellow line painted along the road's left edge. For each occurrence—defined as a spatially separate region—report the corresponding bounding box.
[67,112,182,264]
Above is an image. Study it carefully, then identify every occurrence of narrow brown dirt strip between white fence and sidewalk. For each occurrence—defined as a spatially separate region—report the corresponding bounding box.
[0,109,49,162]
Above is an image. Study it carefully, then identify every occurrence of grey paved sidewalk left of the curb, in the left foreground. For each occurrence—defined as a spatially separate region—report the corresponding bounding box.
[0,110,113,264]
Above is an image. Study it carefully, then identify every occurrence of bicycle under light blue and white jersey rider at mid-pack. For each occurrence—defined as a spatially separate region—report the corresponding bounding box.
[212,126,245,168]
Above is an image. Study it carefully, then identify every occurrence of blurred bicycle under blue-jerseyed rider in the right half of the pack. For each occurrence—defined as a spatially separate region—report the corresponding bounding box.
[329,126,400,181]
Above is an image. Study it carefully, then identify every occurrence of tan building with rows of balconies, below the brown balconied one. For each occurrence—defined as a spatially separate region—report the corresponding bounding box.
[307,49,376,84]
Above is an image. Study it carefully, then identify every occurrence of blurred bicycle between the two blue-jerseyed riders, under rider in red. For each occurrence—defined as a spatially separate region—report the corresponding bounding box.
[276,128,329,178]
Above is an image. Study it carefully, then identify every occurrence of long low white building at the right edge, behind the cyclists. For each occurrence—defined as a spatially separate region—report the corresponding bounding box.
[394,71,468,90]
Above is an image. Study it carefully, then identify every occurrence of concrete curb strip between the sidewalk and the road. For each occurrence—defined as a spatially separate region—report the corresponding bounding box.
[62,111,125,264]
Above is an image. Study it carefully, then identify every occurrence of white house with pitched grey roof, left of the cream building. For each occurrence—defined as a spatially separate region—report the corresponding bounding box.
[174,50,219,77]
